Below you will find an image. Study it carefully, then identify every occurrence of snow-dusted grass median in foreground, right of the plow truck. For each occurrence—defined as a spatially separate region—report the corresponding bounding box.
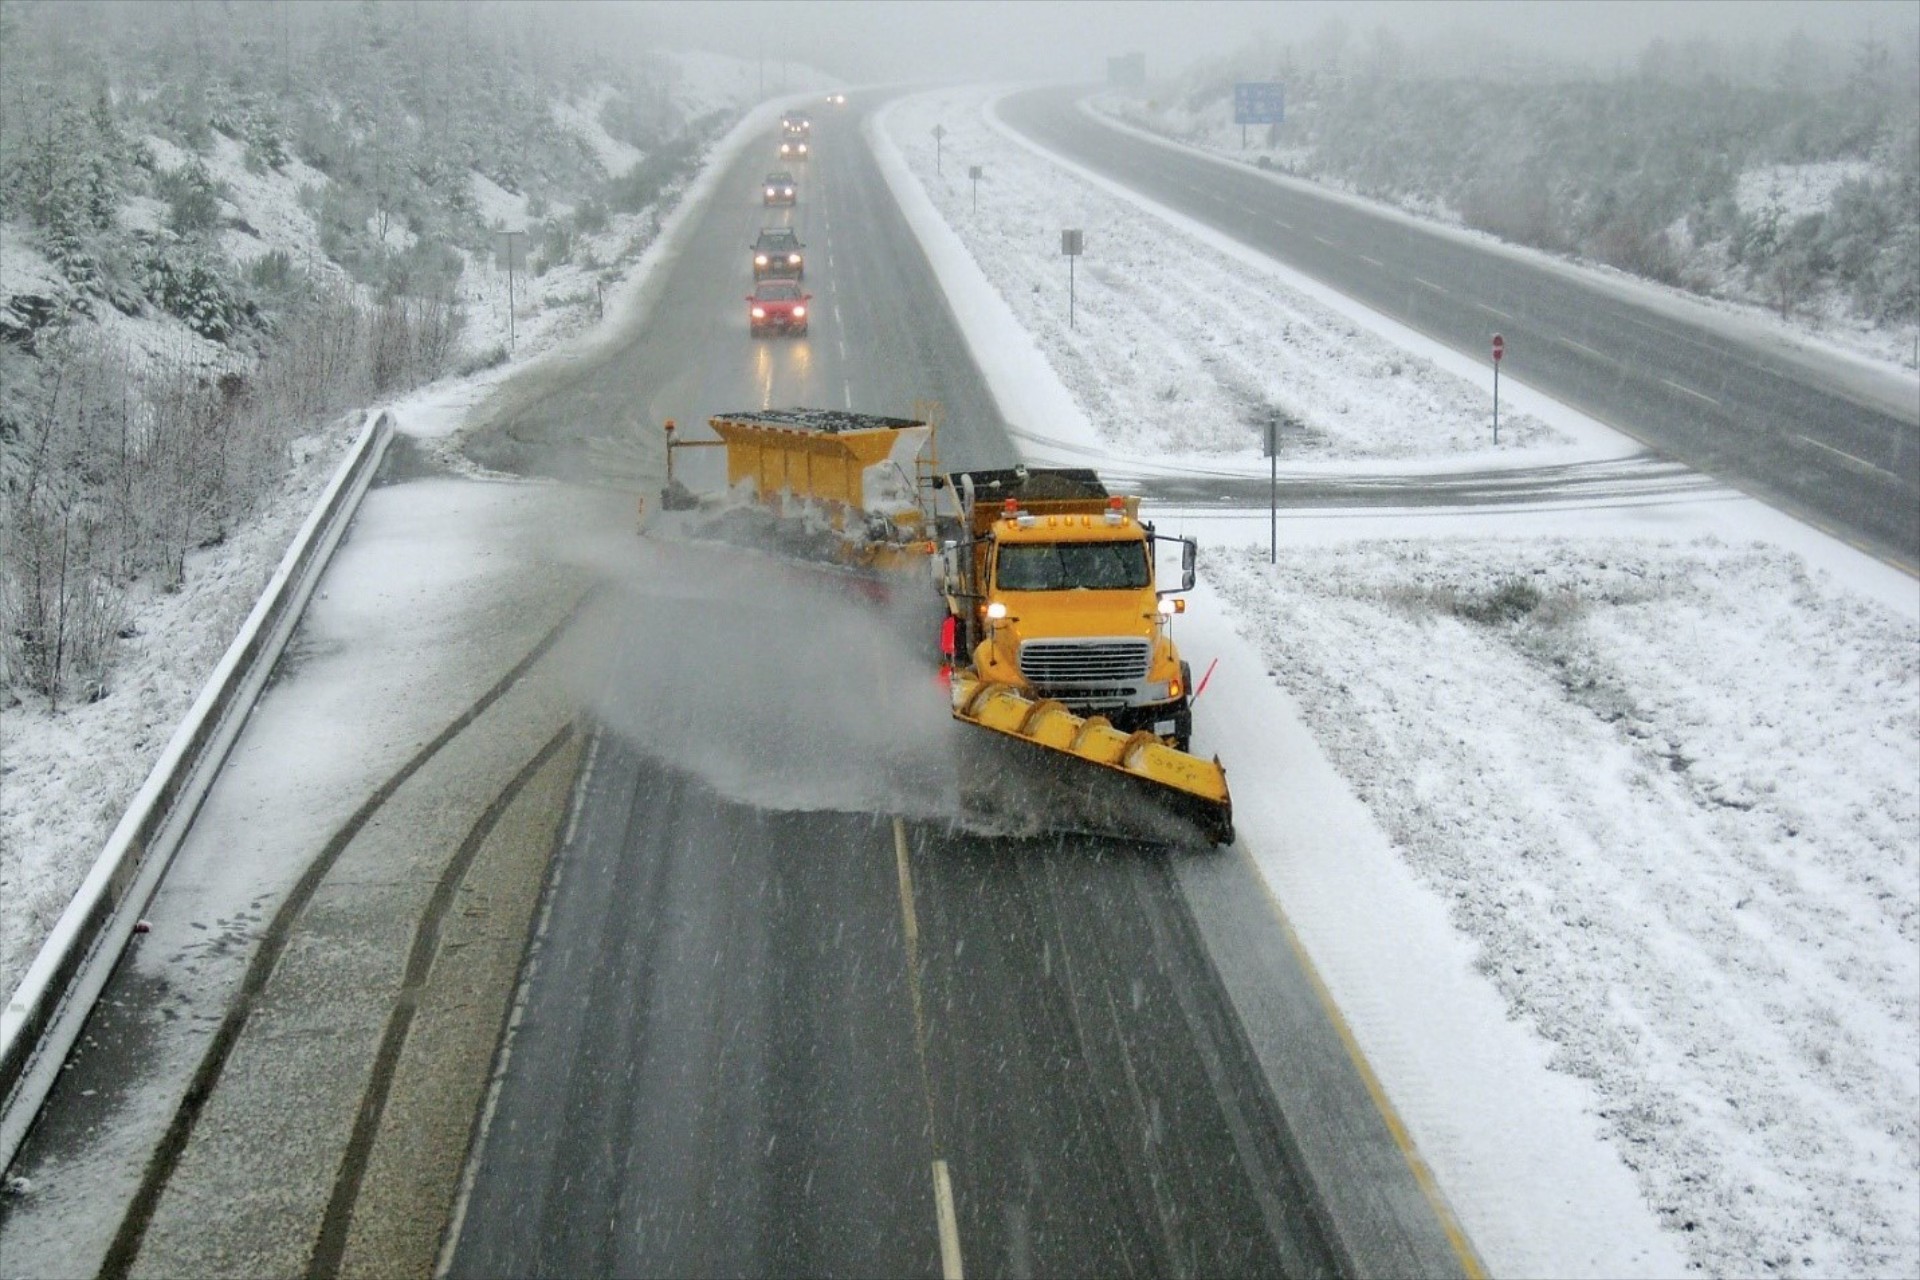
[1206,539,1920,1276]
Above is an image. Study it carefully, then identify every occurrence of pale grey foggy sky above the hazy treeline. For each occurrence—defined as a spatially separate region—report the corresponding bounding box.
[632,0,1920,81]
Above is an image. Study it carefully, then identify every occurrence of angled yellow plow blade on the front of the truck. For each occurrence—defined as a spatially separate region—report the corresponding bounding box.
[952,672,1233,846]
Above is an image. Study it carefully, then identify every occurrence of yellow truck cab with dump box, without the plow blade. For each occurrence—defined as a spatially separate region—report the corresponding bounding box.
[937,468,1196,750]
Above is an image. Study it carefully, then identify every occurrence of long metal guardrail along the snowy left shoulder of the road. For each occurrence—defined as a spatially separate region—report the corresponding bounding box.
[0,411,394,1169]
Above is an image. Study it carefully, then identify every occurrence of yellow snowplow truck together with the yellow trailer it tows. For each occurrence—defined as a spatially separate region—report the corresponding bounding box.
[662,409,1233,844]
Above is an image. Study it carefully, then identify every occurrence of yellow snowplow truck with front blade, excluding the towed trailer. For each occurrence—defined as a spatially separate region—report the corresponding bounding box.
[935,466,1233,844]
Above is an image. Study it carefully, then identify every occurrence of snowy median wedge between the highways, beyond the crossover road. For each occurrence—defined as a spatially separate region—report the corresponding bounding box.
[885,88,1567,464]
